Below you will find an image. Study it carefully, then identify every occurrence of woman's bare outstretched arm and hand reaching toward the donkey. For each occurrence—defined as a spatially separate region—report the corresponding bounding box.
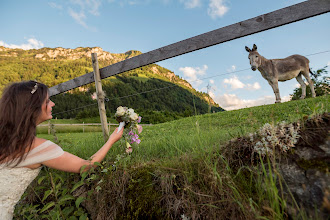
[42,128,124,173]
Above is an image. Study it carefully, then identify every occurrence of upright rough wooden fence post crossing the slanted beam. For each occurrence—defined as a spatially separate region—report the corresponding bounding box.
[92,53,109,142]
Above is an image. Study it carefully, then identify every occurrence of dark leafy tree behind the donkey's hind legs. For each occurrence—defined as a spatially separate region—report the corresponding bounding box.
[291,66,330,100]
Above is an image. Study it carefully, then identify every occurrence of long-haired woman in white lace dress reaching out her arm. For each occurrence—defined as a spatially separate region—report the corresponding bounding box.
[0,81,123,220]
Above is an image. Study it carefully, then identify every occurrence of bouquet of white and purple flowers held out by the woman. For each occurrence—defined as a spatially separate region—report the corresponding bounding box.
[115,106,142,154]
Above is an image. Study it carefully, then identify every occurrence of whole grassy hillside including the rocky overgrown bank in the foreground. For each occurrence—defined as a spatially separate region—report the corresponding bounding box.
[16,96,330,220]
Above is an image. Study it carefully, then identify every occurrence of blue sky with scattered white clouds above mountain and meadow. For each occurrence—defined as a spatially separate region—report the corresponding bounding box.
[0,0,330,110]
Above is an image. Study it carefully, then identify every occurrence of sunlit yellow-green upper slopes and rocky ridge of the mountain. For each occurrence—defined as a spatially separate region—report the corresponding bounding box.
[0,46,218,107]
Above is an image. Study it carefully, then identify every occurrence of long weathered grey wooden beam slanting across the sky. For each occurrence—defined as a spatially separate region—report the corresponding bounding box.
[50,0,330,96]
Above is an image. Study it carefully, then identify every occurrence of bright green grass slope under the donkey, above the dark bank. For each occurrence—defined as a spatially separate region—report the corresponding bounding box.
[39,96,330,163]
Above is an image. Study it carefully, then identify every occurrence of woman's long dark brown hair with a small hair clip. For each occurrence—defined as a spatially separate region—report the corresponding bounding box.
[0,81,48,166]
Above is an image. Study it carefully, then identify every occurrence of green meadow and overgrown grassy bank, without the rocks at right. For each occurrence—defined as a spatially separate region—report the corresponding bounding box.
[15,95,330,220]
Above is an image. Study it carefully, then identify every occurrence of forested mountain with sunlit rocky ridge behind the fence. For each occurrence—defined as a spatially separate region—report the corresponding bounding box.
[0,46,223,124]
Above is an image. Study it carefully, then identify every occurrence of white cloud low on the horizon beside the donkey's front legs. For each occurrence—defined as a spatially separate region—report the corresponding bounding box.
[212,94,291,111]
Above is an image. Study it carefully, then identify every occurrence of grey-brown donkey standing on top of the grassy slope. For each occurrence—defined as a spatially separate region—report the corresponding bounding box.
[245,44,316,103]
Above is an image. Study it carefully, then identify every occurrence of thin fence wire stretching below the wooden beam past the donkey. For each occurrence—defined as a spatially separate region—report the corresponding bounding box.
[53,50,330,115]
